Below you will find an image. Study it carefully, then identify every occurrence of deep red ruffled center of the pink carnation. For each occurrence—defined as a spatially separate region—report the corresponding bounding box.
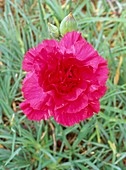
[43,62,80,95]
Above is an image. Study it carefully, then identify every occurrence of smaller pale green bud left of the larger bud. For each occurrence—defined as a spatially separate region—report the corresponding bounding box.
[48,23,59,38]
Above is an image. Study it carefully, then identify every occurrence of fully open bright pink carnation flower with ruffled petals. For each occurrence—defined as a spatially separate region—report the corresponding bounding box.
[20,31,108,126]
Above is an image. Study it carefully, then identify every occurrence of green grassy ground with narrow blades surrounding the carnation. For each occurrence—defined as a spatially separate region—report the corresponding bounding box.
[0,0,126,170]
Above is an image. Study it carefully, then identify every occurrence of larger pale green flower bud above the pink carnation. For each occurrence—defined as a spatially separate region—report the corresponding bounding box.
[60,12,78,36]
